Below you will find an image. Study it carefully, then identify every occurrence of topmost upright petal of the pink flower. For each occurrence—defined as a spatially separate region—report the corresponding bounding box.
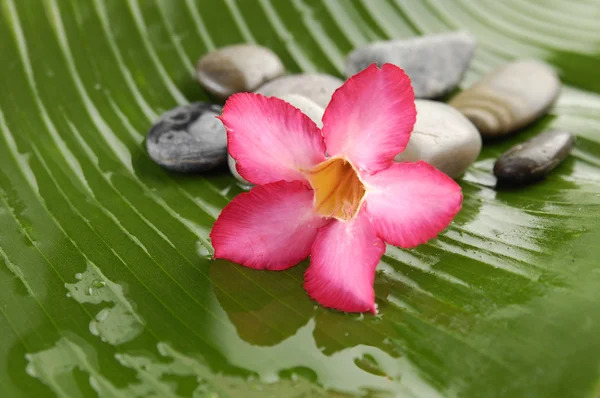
[323,64,416,173]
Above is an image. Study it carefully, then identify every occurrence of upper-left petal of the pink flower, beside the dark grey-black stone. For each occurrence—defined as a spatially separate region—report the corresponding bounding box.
[221,93,325,184]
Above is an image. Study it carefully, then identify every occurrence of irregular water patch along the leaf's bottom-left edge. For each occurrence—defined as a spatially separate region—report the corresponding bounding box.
[25,337,327,398]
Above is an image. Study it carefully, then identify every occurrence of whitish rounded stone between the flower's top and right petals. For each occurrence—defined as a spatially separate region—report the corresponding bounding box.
[394,100,481,178]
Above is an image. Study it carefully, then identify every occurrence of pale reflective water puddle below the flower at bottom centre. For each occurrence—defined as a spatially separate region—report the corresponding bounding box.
[209,318,441,398]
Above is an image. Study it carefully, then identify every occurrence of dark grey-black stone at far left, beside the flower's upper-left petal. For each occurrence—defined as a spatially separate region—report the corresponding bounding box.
[146,102,227,172]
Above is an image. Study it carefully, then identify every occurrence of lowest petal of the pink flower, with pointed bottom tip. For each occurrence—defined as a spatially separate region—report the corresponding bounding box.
[304,211,385,313]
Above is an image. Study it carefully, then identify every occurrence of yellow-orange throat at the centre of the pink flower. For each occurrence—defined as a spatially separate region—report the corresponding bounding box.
[306,158,366,220]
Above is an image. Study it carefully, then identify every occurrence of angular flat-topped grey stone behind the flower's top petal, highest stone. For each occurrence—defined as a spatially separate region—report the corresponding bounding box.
[345,32,477,98]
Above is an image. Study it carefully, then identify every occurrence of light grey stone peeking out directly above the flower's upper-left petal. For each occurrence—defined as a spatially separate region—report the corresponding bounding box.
[256,73,344,109]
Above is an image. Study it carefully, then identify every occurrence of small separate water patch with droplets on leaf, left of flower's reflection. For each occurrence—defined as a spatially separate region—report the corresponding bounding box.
[65,263,145,345]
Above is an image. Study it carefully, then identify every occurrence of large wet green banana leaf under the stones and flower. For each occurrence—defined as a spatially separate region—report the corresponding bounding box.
[0,0,600,398]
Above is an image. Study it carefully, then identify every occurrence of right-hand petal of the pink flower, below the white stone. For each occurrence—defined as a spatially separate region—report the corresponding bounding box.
[363,161,462,248]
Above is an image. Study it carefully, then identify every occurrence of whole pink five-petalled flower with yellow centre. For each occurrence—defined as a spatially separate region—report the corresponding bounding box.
[210,64,462,313]
